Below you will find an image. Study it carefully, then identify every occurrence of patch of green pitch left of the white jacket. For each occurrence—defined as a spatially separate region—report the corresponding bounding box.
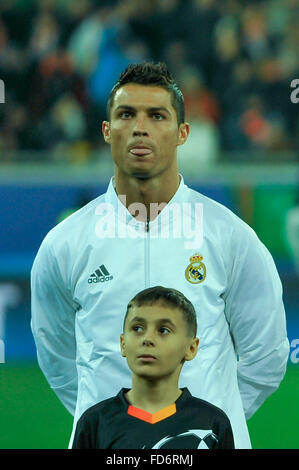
[0,364,73,449]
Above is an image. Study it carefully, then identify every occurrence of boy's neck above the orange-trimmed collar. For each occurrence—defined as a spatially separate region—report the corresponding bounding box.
[126,378,183,414]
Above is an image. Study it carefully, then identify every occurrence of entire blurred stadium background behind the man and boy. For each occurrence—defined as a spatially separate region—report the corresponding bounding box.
[0,0,299,449]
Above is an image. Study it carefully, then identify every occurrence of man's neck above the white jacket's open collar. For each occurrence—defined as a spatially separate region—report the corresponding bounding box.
[115,172,180,221]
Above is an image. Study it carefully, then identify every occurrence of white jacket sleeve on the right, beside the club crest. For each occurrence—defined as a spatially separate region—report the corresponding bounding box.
[224,223,289,419]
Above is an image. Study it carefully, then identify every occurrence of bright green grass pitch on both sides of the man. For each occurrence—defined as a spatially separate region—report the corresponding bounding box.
[0,364,299,449]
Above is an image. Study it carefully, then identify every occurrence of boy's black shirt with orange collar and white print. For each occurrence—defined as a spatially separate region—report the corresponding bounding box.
[72,388,234,449]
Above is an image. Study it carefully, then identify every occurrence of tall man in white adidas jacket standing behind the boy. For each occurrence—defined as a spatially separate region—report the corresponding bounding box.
[32,63,289,448]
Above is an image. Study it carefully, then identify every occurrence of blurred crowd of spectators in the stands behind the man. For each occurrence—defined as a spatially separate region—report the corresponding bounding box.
[0,0,299,163]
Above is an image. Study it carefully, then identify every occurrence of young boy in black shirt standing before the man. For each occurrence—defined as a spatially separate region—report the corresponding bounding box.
[73,286,234,449]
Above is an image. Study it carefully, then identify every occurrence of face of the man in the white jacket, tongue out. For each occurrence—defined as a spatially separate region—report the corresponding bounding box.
[102,83,189,178]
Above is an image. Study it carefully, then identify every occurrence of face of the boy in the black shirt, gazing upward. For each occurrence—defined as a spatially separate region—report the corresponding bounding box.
[120,302,199,379]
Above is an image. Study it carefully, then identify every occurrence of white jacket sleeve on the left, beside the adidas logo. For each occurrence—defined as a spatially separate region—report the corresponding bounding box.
[31,237,78,415]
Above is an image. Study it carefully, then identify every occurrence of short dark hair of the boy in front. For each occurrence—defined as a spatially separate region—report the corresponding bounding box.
[123,286,197,338]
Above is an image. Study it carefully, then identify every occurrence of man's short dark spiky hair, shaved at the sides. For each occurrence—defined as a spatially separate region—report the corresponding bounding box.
[106,62,185,126]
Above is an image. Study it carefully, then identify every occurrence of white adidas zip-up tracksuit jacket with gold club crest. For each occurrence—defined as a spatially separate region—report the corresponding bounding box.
[31,177,289,448]
